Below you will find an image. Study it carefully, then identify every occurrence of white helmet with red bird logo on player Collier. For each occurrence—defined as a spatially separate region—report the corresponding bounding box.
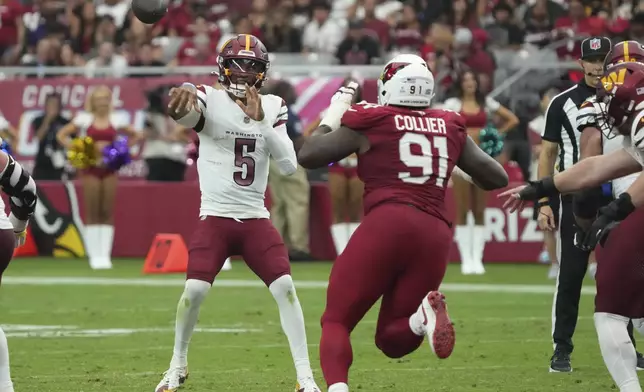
[378,54,434,107]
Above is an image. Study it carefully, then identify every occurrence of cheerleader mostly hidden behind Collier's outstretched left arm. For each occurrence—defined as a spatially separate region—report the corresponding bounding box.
[304,77,364,255]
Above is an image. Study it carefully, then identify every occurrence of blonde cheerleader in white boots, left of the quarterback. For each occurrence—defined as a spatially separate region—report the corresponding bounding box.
[56,86,138,269]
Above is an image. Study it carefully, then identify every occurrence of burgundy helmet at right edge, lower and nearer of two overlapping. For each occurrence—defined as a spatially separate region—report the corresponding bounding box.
[597,62,644,137]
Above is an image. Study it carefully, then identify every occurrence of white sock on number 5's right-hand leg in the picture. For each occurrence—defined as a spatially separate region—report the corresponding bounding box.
[268,275,313,380]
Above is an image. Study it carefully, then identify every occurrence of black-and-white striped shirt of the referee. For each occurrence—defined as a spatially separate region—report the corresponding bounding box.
[541,80,595,172]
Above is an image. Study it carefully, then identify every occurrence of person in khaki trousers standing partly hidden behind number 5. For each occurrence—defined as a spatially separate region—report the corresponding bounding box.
[268,80,311,261]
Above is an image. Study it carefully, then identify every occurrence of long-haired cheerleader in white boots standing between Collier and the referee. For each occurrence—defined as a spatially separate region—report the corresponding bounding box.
[442,70,519,275]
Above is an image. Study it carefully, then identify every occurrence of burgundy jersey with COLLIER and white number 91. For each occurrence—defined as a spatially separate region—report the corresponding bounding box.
[342,103,467,222]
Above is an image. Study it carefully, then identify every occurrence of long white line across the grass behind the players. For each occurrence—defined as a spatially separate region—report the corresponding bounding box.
[2,276,595,295]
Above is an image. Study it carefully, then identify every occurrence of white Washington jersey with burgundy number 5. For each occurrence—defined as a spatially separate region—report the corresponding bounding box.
[195,85,295,219]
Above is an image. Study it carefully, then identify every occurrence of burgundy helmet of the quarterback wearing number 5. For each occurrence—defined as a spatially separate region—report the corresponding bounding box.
[217,34,270,98]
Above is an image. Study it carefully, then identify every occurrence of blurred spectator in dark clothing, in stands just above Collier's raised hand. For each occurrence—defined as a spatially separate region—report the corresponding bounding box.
[336,21,380,65]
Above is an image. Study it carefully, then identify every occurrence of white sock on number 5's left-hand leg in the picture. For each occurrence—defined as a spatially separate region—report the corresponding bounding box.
[170,279,210,367]
